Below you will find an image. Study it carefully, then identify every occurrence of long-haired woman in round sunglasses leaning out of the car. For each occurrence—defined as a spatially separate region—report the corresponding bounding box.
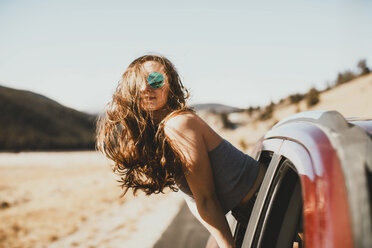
[97,55,265,248]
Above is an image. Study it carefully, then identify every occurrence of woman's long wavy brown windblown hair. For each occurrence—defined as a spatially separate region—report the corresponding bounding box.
[96,55,193,195]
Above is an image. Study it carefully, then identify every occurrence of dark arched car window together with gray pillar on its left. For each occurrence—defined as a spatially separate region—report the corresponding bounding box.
[235,151,304,248]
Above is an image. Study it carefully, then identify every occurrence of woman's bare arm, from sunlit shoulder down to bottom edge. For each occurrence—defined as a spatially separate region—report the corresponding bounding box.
[164,113,235,248]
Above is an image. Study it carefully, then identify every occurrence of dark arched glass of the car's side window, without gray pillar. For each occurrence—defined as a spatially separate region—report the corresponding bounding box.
[253,159,303,248]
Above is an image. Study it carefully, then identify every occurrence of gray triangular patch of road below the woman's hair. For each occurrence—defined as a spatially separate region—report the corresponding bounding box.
[153,203,209,248]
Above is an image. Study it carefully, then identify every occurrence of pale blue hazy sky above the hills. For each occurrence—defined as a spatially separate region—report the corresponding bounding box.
[0,0,372,113]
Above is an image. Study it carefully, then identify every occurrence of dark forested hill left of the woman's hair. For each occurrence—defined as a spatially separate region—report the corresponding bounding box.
[0,86,96,151]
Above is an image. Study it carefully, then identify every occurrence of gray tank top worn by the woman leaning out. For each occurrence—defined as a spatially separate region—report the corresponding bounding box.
[176,139,259,214]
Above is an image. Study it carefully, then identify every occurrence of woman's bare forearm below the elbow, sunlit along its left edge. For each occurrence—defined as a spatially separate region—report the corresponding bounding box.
[195,195,235,248]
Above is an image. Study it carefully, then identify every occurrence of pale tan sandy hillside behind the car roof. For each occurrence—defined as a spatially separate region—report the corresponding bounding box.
[200,73,372,151]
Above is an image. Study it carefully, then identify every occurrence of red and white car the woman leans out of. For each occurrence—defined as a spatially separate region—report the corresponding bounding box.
[222,111,372,248]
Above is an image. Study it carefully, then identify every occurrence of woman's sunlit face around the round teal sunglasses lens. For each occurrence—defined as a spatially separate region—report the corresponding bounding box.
[140,61,169,111]
